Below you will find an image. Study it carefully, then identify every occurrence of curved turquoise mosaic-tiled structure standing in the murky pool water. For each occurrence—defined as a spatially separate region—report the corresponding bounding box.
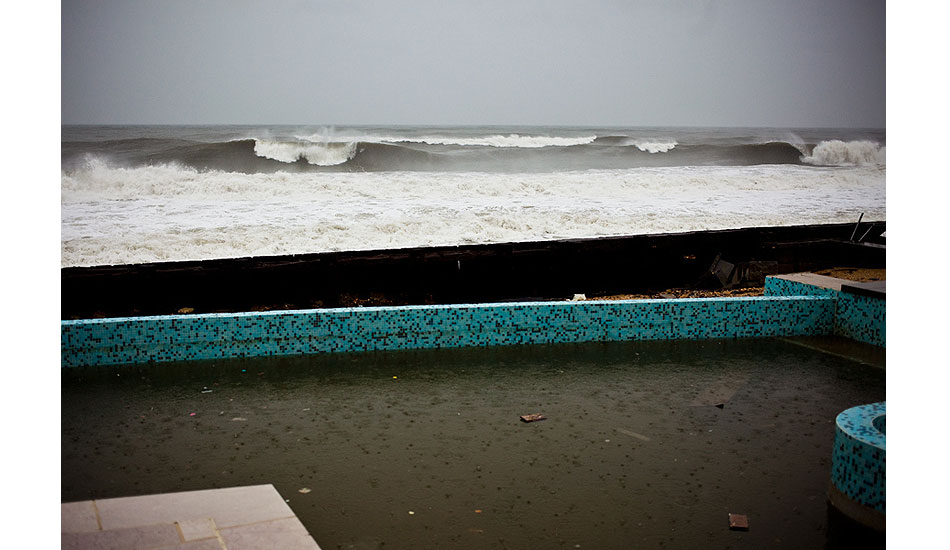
[831,402,887,513]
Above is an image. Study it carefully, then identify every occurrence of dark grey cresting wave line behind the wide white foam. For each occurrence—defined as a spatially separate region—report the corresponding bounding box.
[62,136,856,174]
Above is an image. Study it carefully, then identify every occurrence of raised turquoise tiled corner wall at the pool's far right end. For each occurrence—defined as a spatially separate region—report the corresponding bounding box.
[765,277,887,347]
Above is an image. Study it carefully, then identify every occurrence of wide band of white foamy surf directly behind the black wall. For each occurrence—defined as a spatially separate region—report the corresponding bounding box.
[61,160,885,266]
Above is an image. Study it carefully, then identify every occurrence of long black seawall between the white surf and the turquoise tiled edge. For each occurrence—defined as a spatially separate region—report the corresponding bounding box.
[61,222,885,319]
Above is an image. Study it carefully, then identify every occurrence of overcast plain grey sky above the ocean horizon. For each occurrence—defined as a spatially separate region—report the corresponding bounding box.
[62,0,885,127]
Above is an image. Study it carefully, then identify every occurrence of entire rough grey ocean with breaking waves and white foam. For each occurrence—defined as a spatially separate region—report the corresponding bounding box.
[61,125,886,267]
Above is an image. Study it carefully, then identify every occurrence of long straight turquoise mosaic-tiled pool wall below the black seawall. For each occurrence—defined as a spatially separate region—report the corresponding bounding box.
[61,296,835,367]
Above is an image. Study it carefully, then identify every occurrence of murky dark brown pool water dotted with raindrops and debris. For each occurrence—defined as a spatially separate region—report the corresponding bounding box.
[62,340,885,550]
